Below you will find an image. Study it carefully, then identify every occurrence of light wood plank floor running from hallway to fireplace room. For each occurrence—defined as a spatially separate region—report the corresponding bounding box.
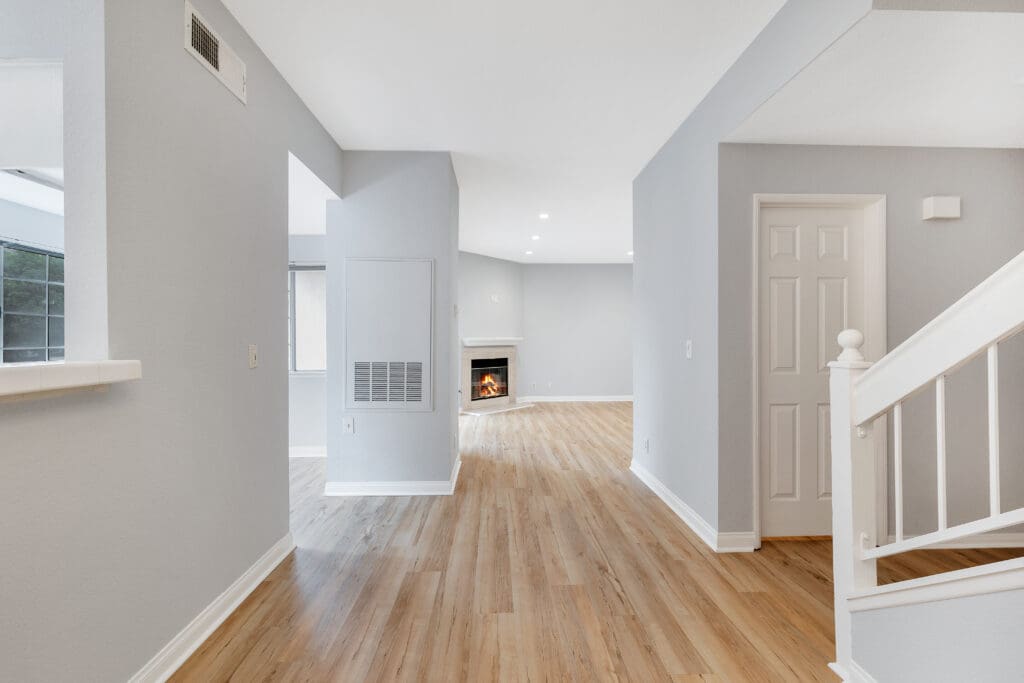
[174,403,1019,683]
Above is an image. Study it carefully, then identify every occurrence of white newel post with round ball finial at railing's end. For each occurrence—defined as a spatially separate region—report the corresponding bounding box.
[828,330,877,680]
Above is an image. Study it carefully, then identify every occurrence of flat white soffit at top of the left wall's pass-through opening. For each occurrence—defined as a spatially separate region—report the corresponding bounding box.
[0,59,63,168]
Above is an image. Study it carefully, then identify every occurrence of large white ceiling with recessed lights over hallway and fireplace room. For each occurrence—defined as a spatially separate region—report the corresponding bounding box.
[225,0,783,262]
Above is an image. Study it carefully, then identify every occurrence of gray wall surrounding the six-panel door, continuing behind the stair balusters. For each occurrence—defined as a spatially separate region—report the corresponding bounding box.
[719,144,1024,533]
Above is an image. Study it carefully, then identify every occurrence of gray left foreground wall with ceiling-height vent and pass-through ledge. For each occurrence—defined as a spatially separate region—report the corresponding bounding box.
[0,0,342,681]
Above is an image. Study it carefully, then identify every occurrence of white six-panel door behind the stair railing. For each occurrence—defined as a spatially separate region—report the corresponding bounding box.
[758,207,864,537]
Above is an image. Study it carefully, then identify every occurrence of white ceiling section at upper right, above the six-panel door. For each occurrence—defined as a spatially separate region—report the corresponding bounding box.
[729,11,1024,147]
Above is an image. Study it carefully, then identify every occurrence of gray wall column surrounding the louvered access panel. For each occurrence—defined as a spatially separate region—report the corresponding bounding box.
[327,152,459,482]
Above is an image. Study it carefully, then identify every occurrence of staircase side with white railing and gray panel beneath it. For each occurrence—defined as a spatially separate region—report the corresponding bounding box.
[829,254,1024,683]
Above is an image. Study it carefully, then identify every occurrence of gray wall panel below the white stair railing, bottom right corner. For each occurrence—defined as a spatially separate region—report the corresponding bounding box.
[853,590,1024,683]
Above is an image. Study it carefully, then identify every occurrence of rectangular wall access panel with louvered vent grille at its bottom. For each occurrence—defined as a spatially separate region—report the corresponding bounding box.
[345,258,434,412]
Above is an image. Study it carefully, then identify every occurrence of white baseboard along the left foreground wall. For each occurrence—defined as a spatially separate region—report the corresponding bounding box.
[128,532,295,683]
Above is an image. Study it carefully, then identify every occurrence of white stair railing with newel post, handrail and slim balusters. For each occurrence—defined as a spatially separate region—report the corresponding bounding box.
[829,253,1024,680]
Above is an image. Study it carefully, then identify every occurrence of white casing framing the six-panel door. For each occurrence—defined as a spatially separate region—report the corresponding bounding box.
[751,193,889,548]
